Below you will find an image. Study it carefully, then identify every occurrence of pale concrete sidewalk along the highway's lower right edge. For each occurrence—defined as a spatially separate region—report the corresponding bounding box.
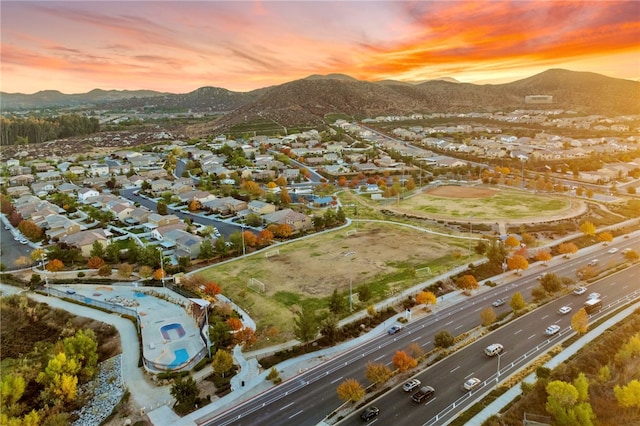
[466,303,640,426]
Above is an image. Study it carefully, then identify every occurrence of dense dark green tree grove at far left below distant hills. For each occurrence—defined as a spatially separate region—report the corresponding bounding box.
[0,114,100,145]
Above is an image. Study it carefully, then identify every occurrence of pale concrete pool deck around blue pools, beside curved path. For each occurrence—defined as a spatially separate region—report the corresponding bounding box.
[52,284,205,371]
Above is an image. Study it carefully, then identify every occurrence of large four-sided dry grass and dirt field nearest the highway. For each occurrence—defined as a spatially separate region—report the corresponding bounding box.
[202,223,468,340]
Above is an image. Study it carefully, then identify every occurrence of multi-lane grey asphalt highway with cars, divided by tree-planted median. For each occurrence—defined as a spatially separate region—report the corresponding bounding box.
[201,236,640,425]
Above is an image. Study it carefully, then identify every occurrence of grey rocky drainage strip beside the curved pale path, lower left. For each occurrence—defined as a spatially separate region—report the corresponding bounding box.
[72,354,124,426]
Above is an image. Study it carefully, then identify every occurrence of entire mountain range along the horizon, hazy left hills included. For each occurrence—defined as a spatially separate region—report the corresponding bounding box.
[0,69,640,130]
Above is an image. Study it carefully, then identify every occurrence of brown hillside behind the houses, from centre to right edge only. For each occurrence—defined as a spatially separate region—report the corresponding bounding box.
[208,69,640,131]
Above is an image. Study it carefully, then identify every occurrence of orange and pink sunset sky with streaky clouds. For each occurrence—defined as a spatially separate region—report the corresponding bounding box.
[0,0,640,93]
